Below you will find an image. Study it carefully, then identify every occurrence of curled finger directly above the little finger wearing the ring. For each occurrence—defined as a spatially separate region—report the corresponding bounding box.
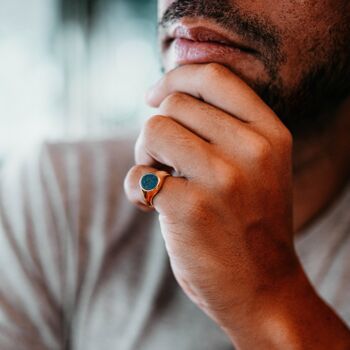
[135,115,212,179]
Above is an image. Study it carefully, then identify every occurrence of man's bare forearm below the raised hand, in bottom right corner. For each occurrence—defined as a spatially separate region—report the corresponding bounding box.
[226,271,350,350]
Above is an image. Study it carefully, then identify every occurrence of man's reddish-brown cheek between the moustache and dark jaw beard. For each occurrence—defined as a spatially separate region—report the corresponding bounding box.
[262,0,341,88]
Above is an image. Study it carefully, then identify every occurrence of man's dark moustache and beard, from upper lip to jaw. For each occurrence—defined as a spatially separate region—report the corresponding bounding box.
[159,0,350,140]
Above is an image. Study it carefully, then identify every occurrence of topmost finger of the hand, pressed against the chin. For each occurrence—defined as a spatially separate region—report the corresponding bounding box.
[147,63,281,134]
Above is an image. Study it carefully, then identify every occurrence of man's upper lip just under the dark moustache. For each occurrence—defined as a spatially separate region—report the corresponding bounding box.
[162,24,257,53]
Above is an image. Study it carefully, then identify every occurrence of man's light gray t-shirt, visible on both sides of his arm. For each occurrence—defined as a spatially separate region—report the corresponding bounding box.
[0,138,350,350]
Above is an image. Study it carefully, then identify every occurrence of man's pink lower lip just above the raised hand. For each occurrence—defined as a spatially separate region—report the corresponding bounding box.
[171,38,255,66]
